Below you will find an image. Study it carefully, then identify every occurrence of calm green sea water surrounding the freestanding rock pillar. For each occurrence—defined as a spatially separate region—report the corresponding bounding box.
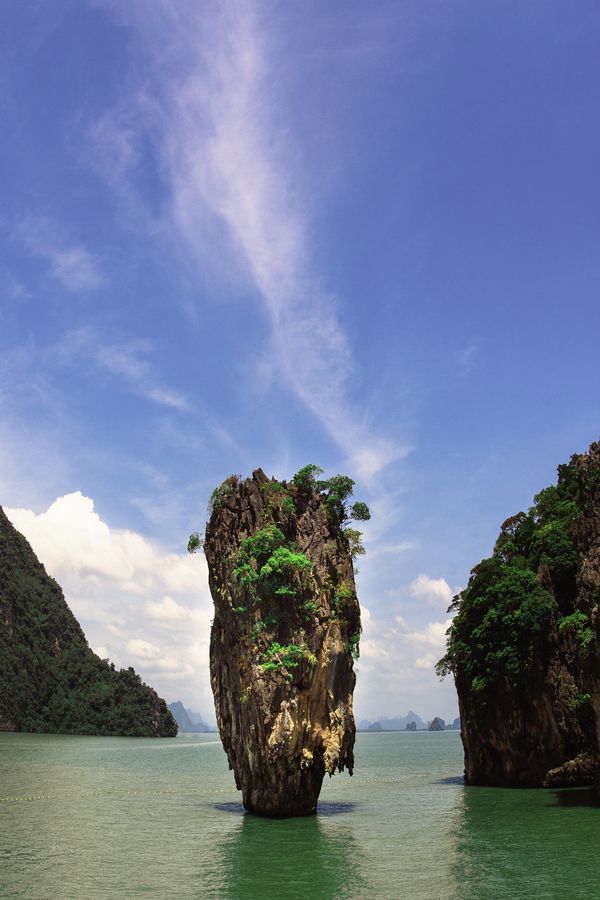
[0,732,600,900]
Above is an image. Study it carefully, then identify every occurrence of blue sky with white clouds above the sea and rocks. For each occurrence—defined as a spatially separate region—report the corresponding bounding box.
[0,0,600,721]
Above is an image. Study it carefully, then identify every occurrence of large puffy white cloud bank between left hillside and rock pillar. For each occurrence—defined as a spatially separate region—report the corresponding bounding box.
[5,491,213,717]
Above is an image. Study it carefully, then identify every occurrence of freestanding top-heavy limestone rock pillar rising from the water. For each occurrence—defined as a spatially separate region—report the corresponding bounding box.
[204,469,360,817]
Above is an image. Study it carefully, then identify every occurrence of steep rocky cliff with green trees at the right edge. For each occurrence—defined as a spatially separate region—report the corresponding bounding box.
[438,443,600,786]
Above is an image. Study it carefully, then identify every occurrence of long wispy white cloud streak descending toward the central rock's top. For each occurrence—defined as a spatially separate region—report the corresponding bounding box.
[95,0,406,479]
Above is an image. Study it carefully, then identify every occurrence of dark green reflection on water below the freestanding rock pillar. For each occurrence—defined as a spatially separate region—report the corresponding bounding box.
[216,804,363,900]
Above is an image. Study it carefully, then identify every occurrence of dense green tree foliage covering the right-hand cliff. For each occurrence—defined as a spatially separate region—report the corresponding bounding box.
[436,465,594,700]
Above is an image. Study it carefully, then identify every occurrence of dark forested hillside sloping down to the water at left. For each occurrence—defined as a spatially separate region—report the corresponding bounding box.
[0,509,177,737]
